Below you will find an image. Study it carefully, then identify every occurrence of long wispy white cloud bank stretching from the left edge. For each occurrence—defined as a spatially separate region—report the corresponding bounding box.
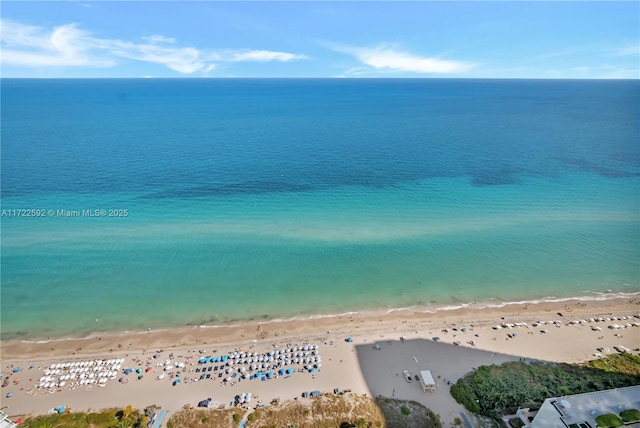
[0,19,307,74]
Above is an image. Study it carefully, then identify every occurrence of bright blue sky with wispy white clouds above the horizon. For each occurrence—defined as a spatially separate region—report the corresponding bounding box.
[0,0,640,79]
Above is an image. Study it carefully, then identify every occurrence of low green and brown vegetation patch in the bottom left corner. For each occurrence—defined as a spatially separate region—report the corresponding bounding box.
[20,406,149,428]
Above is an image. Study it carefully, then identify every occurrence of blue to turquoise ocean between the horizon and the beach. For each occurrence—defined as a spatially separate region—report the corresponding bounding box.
[0,79,640,340]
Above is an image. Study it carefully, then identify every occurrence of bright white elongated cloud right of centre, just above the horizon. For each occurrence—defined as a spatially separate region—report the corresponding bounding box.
[330,44,475,74]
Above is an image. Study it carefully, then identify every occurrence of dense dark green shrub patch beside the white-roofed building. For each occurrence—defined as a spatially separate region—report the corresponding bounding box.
[451,354,640,418]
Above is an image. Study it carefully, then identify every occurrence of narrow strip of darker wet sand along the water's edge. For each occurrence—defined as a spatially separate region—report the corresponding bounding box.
[0,291,640,361]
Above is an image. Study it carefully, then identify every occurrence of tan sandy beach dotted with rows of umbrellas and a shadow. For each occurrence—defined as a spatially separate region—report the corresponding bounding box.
[2,295,640,426]
